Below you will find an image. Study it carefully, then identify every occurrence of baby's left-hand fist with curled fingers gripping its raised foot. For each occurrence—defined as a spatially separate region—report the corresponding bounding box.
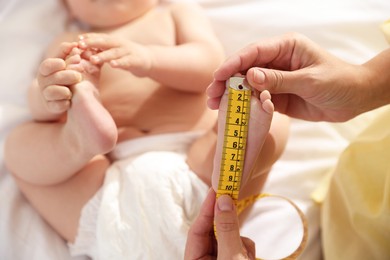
[37,43,82,114]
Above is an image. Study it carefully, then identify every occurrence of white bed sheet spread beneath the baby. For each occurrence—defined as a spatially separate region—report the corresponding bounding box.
[0,0,390,260]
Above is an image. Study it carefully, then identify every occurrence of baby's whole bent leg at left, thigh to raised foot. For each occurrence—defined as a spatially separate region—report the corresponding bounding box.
[5,56,117,241]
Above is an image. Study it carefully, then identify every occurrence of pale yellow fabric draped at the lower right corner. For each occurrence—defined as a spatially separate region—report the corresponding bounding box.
[321,107,390,260]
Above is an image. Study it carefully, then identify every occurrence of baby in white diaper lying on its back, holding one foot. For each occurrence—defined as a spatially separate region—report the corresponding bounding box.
[5,0,286,259]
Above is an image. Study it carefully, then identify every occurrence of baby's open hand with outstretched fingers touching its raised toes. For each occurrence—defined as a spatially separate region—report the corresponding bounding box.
[79,33,152,77]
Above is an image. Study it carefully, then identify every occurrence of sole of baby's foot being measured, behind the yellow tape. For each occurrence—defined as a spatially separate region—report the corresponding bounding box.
[212,88,274,195]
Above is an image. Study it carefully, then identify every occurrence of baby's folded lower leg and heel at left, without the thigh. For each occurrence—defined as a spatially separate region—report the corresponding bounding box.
[5,60,117,185]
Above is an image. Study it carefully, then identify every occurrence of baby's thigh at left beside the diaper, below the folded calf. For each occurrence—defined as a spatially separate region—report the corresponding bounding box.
[15,155,110,242]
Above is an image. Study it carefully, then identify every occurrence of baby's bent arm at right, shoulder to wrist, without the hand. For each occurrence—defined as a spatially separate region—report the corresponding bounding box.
[143,3,225,92]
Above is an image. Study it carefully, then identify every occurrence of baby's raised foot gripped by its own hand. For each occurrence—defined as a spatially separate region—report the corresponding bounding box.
[65,47,117,156]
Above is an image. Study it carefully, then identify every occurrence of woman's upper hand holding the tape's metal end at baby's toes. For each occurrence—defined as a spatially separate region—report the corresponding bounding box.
[207,33,377,121]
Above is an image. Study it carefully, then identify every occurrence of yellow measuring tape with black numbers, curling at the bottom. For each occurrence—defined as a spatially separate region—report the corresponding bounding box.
[214,77,307,259]
